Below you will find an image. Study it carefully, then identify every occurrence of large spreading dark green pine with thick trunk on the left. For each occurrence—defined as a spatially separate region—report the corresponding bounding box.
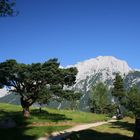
[0,59,77,117]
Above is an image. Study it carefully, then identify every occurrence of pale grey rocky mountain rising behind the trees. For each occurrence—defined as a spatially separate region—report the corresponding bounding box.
[0,56,140,110]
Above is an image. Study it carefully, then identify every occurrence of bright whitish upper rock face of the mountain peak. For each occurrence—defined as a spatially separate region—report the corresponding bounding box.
[74,56,132,82]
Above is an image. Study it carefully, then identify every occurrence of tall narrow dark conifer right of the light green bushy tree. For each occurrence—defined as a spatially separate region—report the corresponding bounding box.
[112,73,125,116]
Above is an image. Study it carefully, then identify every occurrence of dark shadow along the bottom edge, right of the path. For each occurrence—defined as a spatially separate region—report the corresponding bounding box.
[62,129,132,140]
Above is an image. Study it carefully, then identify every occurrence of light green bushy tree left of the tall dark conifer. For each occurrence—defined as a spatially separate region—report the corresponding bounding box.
[90,83,111,113]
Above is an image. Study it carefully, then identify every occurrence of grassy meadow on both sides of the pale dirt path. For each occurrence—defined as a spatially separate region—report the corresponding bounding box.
[0,103,134,140]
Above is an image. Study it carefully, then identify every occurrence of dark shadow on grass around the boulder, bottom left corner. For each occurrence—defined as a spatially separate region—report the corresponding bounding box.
[0,111,36,140]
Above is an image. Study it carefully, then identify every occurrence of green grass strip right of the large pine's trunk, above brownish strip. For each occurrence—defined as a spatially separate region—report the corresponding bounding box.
[28,108,109,123]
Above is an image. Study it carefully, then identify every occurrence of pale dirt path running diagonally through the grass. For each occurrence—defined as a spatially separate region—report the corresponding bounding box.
[38,120,117,140]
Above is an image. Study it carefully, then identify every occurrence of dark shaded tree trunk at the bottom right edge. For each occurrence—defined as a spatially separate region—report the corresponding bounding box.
[133,118,140,140]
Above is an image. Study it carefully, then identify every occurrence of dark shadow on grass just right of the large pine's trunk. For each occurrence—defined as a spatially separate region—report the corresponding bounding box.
[31,109,72,122]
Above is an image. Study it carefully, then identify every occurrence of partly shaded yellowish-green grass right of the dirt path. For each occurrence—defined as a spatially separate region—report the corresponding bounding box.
[64,118,134,140]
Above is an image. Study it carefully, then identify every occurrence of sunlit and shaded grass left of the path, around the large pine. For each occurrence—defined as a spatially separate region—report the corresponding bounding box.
[0,103,108,140]
